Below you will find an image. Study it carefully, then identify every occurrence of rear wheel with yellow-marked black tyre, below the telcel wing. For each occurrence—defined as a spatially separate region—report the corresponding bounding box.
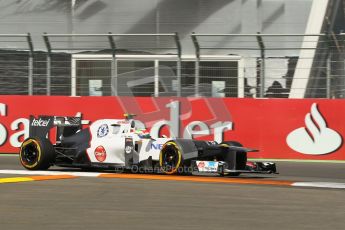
[19,137,55,170]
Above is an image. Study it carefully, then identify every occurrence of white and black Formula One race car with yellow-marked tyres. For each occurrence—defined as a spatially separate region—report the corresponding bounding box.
[19,114,276,176]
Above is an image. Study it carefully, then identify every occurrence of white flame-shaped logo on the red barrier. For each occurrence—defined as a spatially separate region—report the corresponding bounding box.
[286,103,342,155]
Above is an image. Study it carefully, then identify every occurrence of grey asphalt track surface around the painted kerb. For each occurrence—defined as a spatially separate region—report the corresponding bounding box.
[0,155,345,230]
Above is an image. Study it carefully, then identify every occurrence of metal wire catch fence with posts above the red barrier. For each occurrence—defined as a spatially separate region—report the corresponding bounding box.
[0,33,345,98]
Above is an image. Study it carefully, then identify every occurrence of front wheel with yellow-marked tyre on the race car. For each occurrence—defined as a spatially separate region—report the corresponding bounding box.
[159,141,183,175]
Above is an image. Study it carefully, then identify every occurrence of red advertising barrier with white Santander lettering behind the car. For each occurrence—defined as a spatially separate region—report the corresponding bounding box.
[0,96,345,160]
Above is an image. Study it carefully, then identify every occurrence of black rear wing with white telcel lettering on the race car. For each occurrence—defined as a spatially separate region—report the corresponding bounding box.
[29,115,81,138]
